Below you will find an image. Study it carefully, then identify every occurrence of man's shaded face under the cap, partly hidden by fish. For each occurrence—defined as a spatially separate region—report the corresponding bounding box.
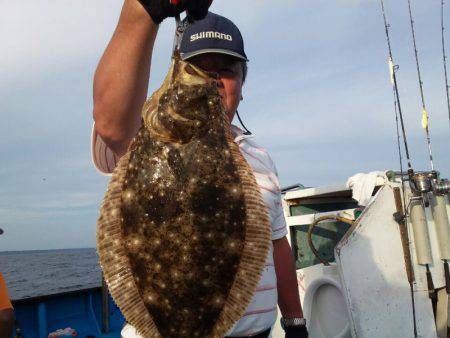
[189,53,243,122]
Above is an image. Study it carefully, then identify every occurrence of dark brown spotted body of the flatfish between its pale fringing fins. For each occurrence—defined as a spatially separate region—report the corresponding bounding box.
[122,78,245,337]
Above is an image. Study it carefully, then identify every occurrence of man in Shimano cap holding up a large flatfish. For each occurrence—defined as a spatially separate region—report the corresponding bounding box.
[92,0,307,338]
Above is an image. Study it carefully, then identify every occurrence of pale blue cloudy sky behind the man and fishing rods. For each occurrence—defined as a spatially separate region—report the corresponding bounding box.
[0,0,450,251]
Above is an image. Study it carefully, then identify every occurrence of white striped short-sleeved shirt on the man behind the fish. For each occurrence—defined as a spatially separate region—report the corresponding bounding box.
[92,125,287,338]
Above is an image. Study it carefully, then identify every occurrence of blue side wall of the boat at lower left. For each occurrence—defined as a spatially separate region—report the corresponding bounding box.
[12,285,125,338]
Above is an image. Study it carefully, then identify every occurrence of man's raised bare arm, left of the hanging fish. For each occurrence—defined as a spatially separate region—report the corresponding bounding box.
[93,0,158,157]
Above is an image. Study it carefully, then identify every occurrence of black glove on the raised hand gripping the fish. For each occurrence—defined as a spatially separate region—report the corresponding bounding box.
[139,0,212,24]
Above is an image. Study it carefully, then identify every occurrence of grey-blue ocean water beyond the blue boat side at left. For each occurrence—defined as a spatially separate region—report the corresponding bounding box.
[0,248,101,300]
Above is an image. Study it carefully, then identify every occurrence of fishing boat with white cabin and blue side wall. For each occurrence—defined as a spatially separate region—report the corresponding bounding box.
[13,172,450,338]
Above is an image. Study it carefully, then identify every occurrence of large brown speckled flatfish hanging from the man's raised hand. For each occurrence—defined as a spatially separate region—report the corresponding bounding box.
[97,54,271,338]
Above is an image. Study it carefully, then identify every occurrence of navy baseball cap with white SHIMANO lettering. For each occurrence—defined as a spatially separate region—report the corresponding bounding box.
[180,12,248,61]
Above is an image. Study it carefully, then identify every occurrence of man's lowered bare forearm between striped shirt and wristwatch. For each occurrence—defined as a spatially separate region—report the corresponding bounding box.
[273,236,303,318]
